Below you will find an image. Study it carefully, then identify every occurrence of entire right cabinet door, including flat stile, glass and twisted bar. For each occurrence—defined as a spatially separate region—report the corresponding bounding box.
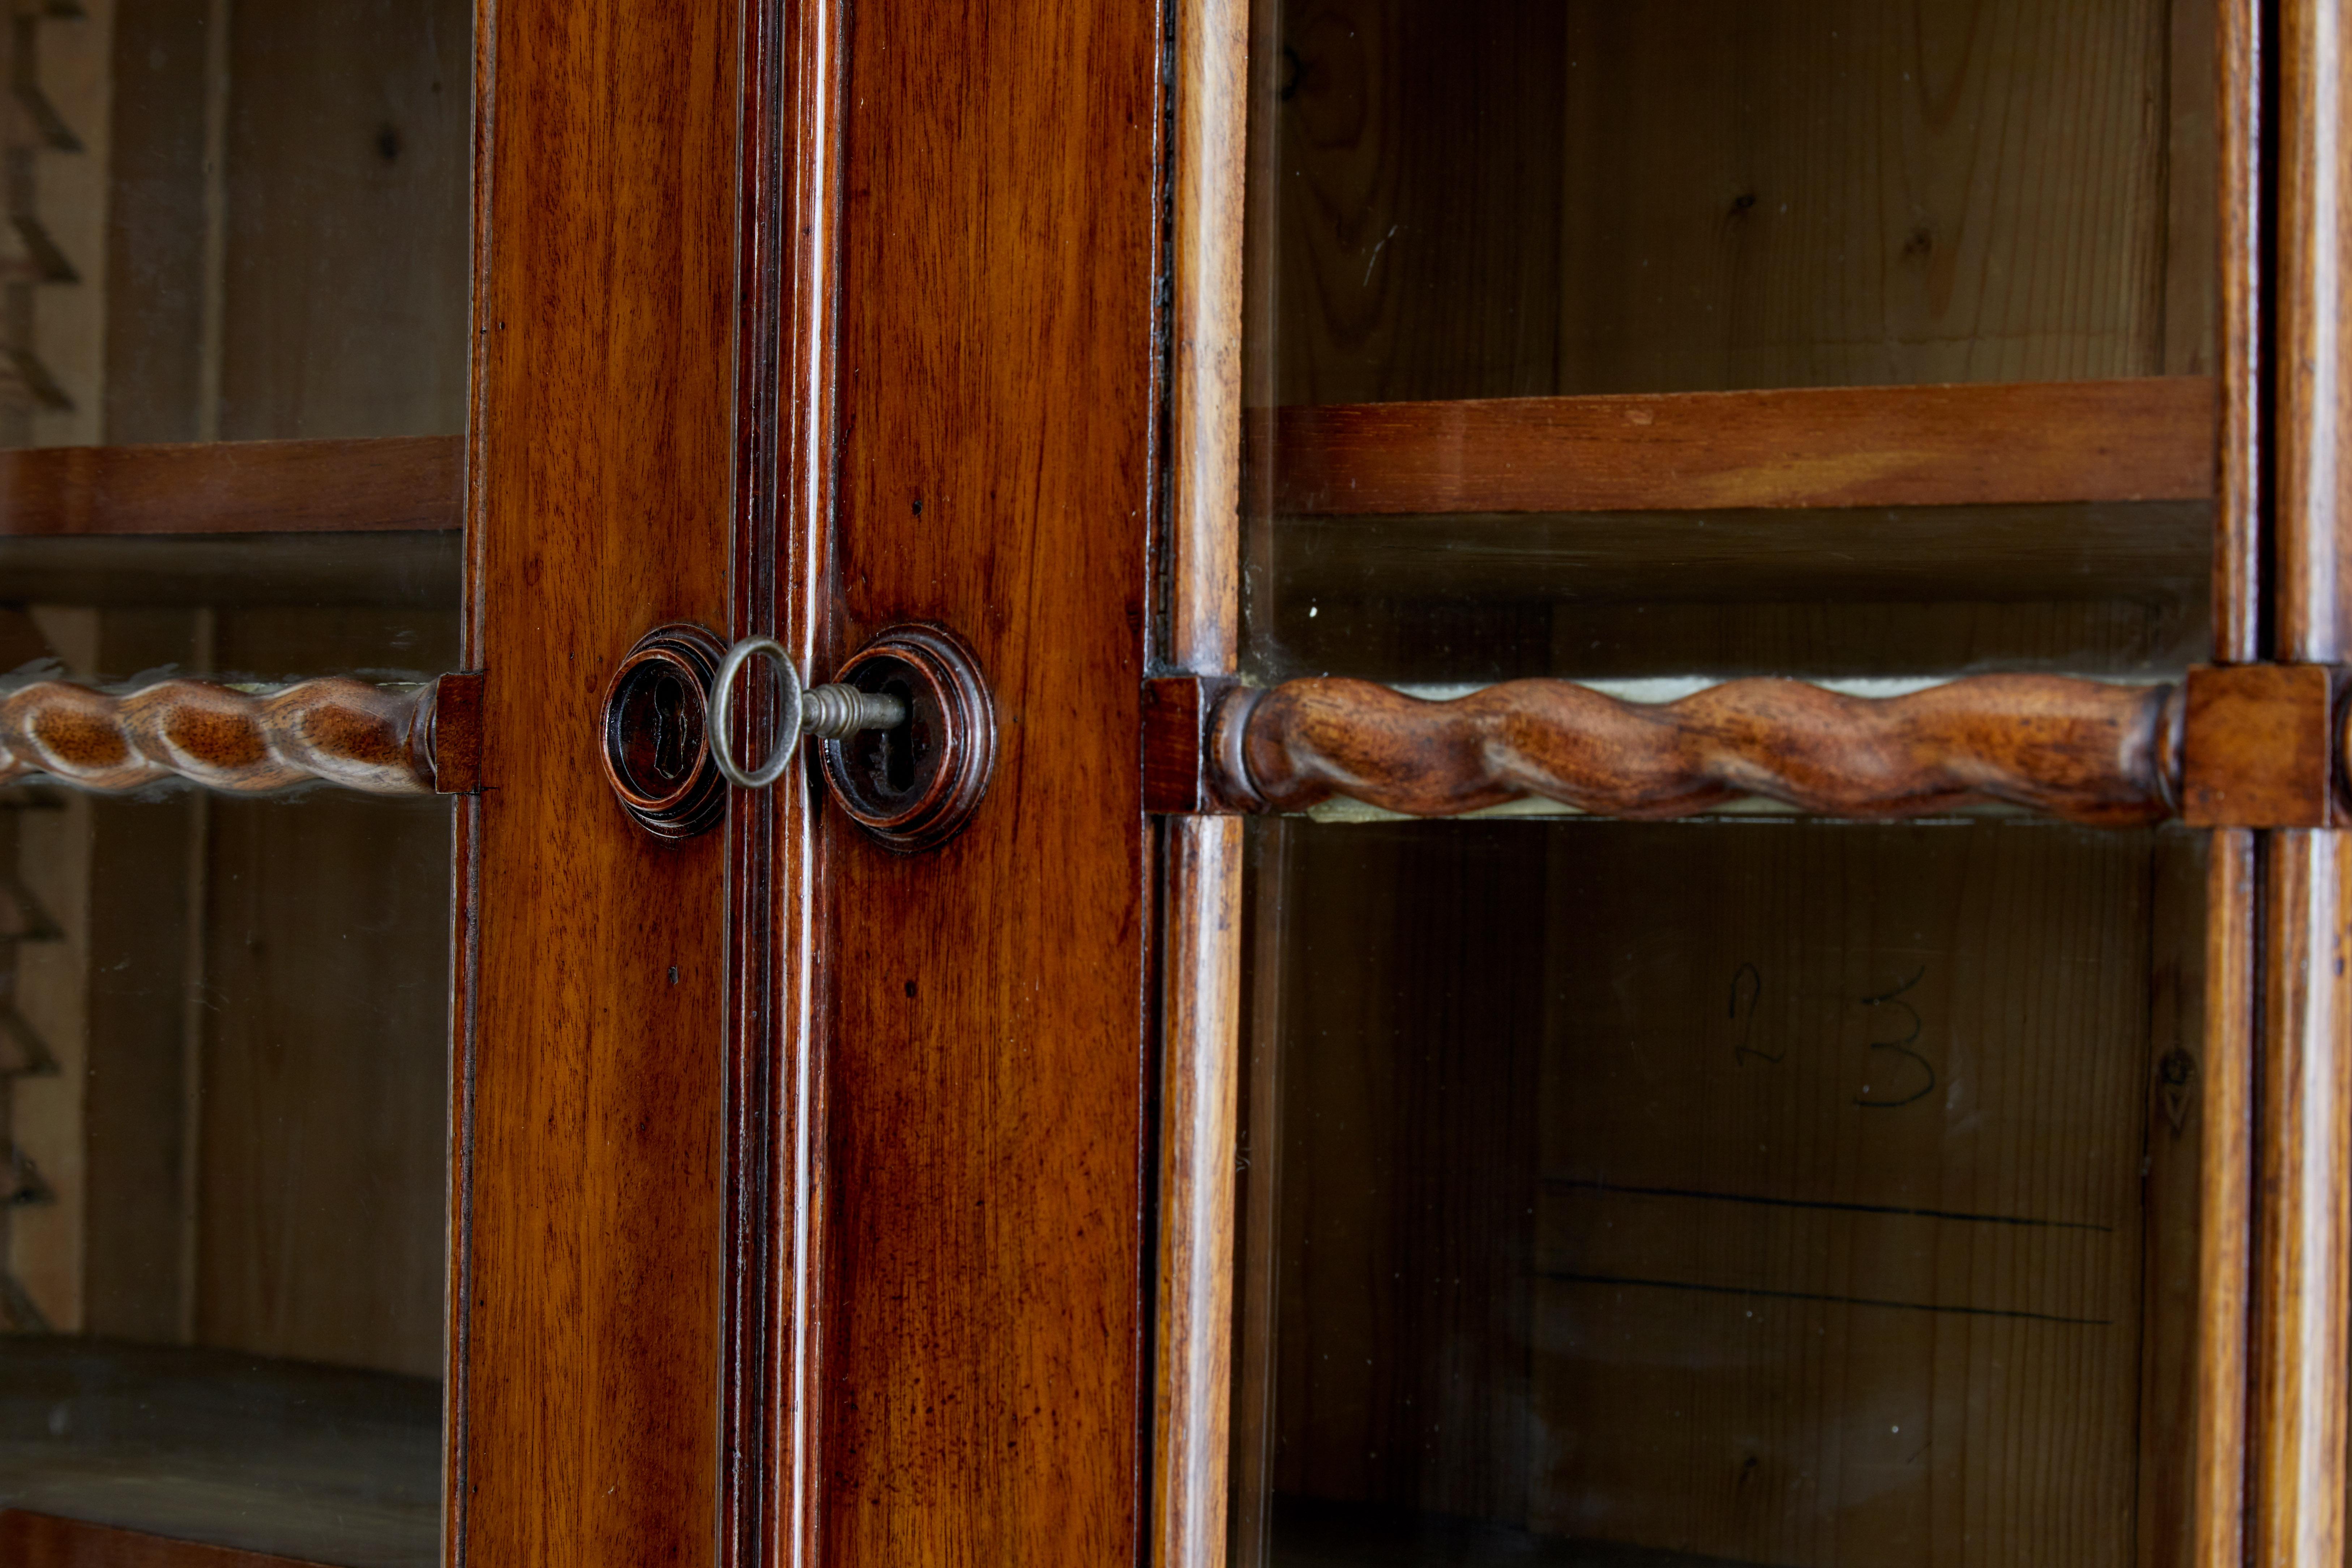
[724,0,2352,1568]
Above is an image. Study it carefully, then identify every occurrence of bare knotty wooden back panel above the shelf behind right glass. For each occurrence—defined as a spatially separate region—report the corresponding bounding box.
[1261,0,2216,404]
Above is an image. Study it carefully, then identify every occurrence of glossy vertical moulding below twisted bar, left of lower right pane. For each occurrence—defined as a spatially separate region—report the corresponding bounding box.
[1150,816,1242,1568]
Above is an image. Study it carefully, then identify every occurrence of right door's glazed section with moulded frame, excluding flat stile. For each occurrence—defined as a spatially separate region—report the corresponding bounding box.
[1145,0,2347,1568]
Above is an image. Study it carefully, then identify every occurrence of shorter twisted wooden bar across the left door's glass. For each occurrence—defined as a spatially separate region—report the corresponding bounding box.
[0,677,433,795]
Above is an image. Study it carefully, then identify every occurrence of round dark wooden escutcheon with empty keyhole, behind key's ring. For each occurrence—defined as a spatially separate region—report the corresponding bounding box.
[600,621,727,839]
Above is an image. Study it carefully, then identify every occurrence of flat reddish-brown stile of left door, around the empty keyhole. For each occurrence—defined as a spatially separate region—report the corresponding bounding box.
[449,0,741,1568]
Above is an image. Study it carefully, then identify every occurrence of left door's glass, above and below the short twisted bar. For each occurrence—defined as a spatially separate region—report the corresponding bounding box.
[0,0,473,1565]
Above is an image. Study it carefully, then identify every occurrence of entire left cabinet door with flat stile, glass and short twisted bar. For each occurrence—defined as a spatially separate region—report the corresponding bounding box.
[0,0,736,1568]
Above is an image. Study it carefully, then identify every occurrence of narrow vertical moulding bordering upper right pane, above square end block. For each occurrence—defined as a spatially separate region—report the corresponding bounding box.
[2213,0,2270,663]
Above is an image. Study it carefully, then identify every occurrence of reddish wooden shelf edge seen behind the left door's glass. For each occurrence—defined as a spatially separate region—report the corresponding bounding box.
[0,435,466,536]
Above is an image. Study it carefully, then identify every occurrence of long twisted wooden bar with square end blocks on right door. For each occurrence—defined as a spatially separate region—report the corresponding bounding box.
[1143,665,2352,828]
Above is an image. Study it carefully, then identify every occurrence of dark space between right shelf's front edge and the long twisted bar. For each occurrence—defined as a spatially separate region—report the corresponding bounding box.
[1246,503,2213,684]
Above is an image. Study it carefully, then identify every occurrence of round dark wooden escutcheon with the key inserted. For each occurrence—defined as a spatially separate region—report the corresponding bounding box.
[826,625,997,853]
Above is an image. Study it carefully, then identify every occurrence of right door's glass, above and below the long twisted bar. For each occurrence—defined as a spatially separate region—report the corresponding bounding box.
[1230,0,2216,1568]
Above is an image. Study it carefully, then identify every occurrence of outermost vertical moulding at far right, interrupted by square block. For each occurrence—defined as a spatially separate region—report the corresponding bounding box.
[2249,0,2352,1568]
